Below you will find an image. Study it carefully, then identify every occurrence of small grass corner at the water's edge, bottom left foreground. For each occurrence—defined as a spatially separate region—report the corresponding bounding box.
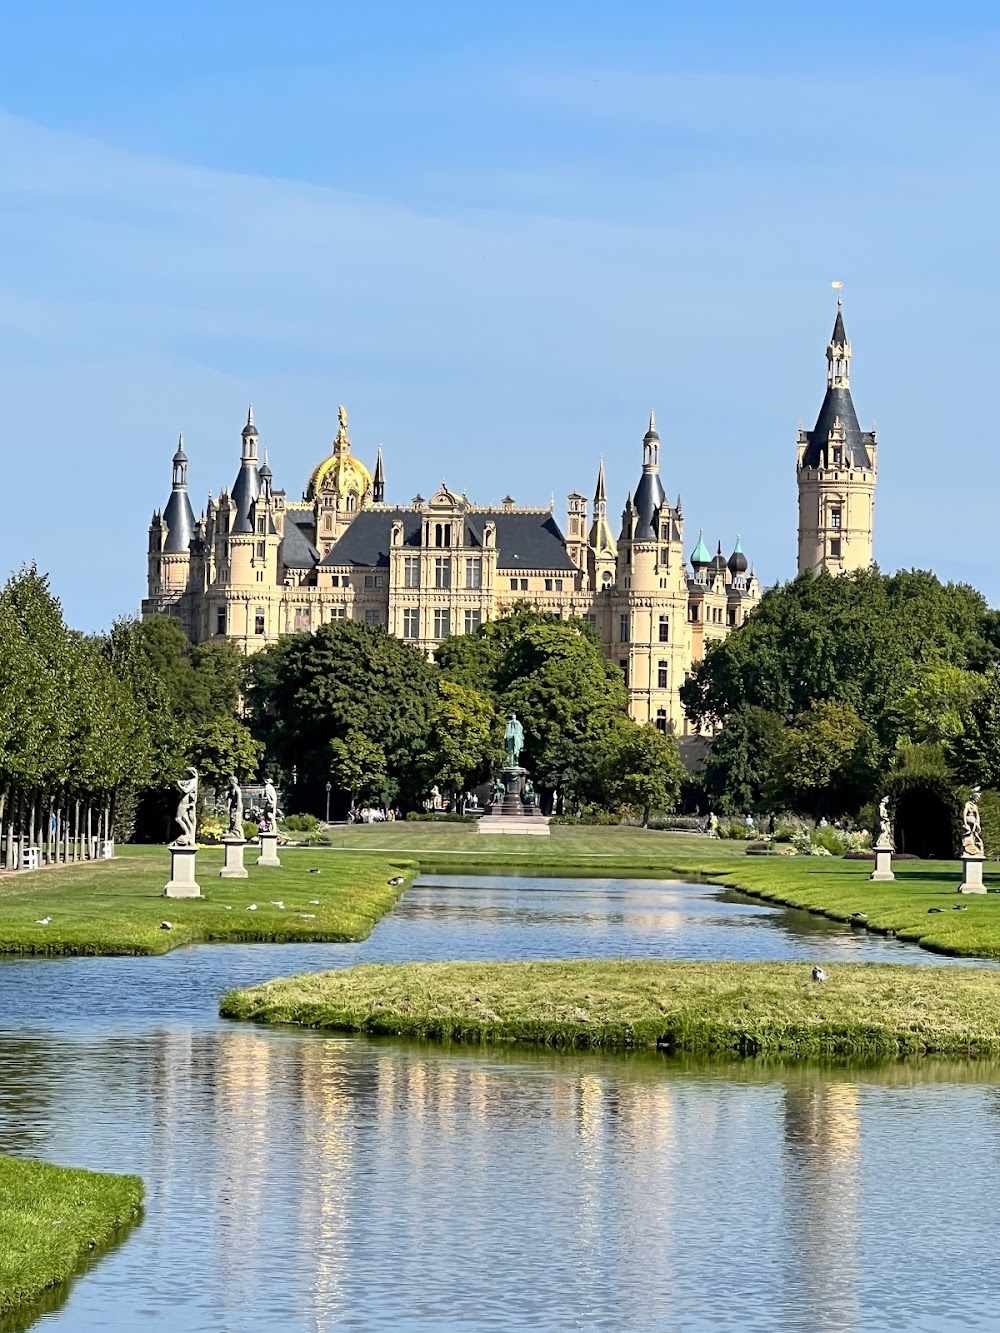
[0,1157,143,1316]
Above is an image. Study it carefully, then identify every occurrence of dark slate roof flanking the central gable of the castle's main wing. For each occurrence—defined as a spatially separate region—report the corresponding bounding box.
[323,509,576,572]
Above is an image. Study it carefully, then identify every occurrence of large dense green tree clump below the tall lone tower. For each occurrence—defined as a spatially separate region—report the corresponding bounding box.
[681,569,1000,816]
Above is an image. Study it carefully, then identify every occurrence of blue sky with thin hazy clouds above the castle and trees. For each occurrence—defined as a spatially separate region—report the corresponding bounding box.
[0,0,1000,629]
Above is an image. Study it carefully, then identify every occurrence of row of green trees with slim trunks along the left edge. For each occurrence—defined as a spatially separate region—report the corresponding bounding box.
[0,568,261,869]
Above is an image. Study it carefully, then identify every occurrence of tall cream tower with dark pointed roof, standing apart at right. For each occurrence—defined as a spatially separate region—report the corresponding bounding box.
[797,300,877,575]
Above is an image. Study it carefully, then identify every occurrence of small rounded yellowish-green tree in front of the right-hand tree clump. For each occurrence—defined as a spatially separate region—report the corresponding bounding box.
[771,700,883,817]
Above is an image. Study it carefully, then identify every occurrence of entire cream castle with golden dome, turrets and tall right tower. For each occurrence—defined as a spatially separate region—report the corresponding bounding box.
[143,303,876,733]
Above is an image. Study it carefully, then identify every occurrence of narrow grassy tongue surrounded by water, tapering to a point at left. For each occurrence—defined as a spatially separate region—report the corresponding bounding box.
[220,961,1000,1058]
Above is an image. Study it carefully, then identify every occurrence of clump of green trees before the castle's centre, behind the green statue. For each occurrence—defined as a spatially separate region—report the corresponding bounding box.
[247,607,684,818]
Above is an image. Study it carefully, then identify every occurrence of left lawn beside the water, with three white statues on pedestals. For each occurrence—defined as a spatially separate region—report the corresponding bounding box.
[0,848,415,954]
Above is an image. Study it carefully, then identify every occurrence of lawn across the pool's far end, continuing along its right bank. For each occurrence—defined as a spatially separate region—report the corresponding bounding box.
[318,824,1000,958]
